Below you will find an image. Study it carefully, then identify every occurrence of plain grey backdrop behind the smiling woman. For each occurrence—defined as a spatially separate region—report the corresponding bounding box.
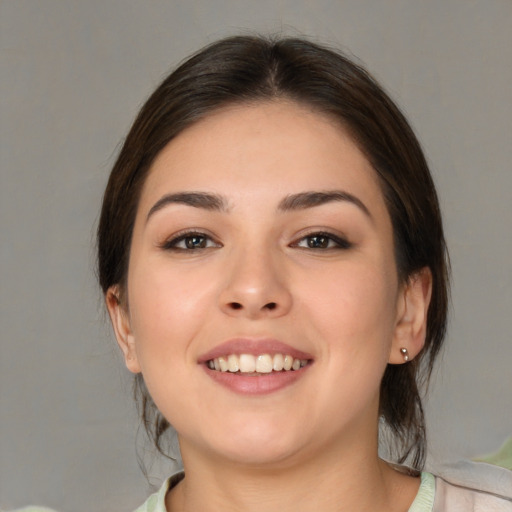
[0,0,512,512]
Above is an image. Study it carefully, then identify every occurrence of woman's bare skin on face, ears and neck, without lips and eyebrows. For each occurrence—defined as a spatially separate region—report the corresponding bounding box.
[107,101,431,512]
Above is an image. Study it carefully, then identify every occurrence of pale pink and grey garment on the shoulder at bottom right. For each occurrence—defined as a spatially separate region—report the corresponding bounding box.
[433,461,512,512]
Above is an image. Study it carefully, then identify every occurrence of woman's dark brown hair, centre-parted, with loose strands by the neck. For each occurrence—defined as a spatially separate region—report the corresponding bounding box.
[98,36,449,468]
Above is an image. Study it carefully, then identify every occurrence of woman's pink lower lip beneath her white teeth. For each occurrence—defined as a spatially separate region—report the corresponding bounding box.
[203,364,310,395]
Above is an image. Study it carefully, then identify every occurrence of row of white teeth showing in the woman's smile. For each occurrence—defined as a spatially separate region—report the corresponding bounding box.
[207,354,308,373]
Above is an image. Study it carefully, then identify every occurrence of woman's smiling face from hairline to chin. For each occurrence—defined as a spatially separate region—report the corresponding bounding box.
[110,102,420,464]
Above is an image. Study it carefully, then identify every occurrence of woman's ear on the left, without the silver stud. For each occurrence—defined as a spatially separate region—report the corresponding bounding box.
[105,285,141,373]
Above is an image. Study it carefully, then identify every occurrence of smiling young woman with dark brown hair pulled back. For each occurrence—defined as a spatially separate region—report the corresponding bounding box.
[98,37,508,512]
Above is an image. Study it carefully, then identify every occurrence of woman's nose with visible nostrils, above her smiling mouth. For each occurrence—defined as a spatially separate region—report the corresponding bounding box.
[220,245,292,320]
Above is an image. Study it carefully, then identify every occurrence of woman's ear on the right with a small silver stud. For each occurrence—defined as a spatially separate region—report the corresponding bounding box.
[389,267,432,364]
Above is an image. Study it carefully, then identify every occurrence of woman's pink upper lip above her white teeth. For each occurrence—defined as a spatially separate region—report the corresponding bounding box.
[198,338,313,364]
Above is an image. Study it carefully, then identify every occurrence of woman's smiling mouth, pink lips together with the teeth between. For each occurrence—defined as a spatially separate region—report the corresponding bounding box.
[198,338,313,395]
